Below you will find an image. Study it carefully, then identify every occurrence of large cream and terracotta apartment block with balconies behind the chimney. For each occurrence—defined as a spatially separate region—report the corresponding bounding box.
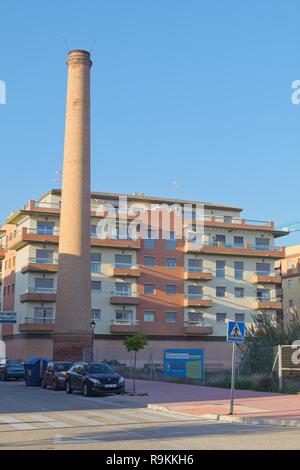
[0,190,286,366]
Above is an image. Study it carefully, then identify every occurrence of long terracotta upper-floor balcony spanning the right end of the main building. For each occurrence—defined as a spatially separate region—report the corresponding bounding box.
[184,242,285,258]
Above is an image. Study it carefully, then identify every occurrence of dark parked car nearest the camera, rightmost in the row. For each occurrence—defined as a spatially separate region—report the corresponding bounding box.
[66,362,125,397]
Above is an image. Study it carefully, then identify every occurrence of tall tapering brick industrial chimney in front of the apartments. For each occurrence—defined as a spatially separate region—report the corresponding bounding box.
[53,50,92,361]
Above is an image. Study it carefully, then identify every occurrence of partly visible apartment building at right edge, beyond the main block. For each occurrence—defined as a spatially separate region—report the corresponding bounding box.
[276,245,300,320]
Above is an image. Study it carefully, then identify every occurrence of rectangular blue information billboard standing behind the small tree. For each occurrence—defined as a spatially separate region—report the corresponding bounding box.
[164,349,204,380]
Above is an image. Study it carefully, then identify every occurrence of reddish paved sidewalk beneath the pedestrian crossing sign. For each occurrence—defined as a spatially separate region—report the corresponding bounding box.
[107,380,300,427]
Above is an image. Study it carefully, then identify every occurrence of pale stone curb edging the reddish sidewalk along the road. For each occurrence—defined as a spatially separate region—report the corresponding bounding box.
[147,404,300,428]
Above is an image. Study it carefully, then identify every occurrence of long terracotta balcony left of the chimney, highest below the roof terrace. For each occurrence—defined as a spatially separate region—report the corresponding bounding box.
[8,227,59,250]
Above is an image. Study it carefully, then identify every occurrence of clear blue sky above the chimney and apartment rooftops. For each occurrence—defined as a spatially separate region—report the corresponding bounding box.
[0,0,300,244]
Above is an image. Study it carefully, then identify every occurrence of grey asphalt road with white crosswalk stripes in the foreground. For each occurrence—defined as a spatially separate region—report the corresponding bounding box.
[0,381,300,451]
